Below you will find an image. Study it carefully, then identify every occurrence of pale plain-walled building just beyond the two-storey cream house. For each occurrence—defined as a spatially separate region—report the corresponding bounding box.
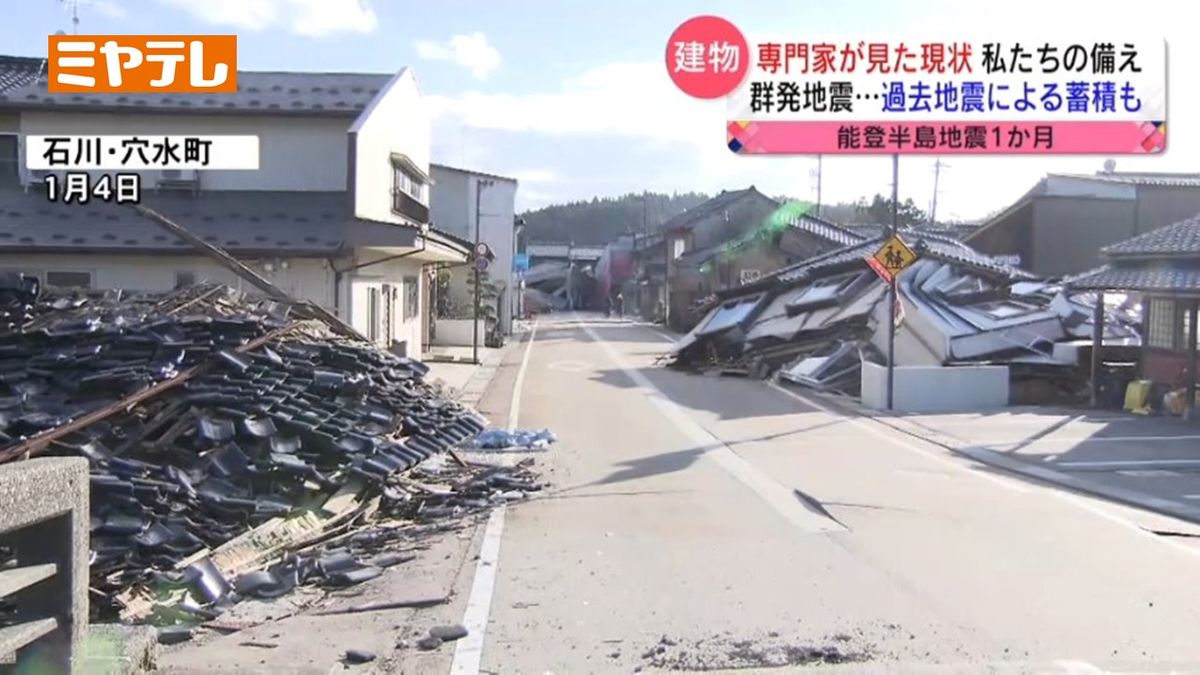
[431,163,521,335]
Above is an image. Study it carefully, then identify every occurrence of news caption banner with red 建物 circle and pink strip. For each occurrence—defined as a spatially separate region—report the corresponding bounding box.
[666,17,1166,155]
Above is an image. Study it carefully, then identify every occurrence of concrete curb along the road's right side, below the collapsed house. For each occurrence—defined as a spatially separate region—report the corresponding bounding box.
[781,384,1200,525]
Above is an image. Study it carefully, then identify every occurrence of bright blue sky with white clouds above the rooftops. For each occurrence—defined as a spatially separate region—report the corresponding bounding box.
[7,0,1200,217]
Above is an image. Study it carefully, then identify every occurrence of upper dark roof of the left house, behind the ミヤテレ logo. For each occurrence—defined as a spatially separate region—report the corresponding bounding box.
[0,71,395,117]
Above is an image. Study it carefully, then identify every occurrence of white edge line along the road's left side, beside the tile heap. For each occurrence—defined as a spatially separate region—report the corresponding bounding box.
[450,319,538,675]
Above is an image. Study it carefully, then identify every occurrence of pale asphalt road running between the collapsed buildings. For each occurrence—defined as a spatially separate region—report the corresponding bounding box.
[460,316,1200,674]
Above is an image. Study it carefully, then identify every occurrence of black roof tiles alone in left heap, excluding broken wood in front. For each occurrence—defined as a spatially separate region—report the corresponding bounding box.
[0,276,486,613]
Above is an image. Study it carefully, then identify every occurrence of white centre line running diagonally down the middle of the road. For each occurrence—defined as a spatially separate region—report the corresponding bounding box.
[582,325,845,532]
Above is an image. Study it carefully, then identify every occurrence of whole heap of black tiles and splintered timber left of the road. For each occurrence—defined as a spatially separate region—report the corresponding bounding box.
[0,279,552,624]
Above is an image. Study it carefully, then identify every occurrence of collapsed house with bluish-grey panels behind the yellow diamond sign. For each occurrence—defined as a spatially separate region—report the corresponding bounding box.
[671,229,1140,402]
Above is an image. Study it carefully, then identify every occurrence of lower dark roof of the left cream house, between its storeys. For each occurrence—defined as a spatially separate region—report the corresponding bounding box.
[0,190,456,256]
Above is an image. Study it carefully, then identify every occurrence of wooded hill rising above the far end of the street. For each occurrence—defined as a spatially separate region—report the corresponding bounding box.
[521,192,708,245]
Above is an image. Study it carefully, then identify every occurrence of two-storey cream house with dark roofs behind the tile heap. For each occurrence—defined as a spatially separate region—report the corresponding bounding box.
[0,56,469,356]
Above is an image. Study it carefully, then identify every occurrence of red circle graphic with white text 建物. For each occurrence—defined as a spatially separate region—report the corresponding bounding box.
[667,16,750,98]
